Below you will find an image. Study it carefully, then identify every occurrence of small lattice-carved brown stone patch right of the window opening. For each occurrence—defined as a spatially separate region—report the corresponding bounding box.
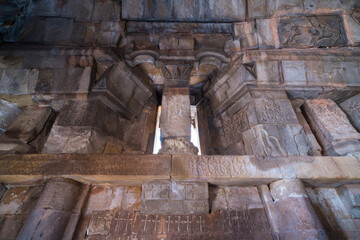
[223,107,249,145]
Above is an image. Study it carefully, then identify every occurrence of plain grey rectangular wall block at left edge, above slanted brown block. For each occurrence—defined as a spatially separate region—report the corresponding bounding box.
[0,69,39,95]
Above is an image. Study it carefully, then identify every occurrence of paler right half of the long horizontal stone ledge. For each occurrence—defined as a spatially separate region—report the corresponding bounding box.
[171,155,360,186]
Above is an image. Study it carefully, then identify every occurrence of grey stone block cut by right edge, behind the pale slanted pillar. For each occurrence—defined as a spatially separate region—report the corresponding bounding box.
[340,94,360,132]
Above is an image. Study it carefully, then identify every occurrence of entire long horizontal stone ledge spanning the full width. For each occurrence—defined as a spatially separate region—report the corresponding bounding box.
[0,154,360,186]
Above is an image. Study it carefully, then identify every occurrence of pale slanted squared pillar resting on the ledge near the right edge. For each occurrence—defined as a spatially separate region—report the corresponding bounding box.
[304,99,360,156]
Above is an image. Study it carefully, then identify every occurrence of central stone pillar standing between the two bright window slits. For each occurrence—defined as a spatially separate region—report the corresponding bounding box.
[159,66,198,154]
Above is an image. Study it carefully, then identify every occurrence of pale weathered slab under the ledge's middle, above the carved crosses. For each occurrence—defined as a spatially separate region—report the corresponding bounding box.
[141,181,209,214]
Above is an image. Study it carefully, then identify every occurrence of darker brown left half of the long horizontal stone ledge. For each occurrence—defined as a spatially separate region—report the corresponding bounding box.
[0,154,171,184]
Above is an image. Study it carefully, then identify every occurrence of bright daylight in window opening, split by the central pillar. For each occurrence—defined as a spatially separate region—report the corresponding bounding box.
[153,106,201,155]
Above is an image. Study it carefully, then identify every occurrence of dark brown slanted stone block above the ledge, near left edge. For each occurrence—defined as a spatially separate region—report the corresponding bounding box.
[3,107,51,143]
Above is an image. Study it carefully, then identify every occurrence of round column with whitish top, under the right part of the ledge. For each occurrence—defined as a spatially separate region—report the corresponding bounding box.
[265,179,327,239]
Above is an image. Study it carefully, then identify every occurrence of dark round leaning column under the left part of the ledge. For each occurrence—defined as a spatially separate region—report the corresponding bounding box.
[17,179,81,240]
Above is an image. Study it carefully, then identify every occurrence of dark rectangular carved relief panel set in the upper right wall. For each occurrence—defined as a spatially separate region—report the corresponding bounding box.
[279,16,346,47]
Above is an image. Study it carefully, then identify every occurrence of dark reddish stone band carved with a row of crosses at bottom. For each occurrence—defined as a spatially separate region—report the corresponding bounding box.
[87,208,271,239]
